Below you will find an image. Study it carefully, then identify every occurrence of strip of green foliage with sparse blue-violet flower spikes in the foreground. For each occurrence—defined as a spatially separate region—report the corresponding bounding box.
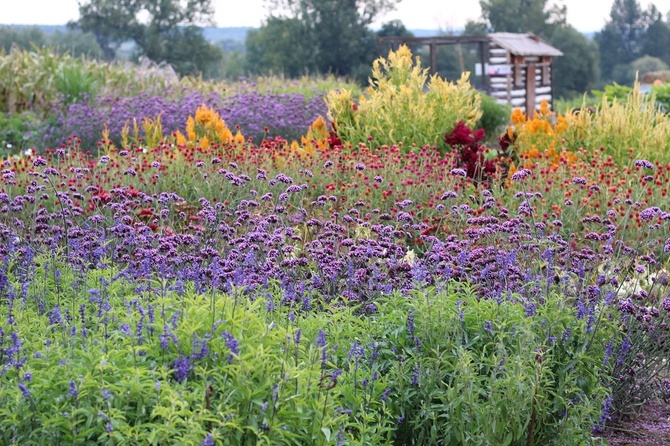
[0,255,610,445]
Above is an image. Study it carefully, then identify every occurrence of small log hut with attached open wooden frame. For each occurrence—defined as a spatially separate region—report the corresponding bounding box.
[378,33,563,112]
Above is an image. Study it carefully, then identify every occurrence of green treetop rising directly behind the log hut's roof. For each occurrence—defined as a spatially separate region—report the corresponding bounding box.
[479,0,567,35]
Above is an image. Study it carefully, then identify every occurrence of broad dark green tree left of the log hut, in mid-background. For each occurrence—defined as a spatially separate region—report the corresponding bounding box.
[247,0,400,76]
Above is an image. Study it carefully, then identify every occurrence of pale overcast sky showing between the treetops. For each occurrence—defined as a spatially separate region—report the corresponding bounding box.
[0,0,670,32]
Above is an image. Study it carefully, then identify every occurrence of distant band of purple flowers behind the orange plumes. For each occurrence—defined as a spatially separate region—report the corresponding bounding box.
[30,89,327,150]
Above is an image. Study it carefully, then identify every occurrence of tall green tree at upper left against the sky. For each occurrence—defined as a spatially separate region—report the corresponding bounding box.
[70,0,220,74]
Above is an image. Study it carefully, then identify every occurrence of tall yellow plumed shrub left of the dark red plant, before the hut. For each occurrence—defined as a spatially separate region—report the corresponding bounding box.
[326,45,482,151]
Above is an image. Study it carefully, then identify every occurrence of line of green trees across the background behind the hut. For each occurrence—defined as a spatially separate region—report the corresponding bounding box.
[5,0,670,97]
